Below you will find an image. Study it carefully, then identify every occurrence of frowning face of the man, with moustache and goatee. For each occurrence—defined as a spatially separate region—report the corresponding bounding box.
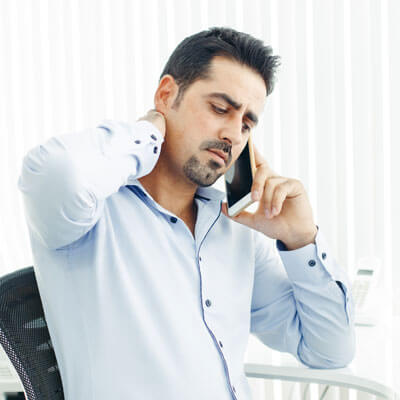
[162,57,266,186]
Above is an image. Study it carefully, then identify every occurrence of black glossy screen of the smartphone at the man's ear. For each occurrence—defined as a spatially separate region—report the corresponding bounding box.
[225,142,253,207]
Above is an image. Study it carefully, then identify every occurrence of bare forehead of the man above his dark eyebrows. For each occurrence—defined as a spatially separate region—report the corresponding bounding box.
[197,57,267,115]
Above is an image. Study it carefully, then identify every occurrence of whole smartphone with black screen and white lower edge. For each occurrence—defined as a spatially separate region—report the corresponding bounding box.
[224,136,256,217]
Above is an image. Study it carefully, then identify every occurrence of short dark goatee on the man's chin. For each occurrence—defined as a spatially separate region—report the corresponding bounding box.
[183,156,222,187]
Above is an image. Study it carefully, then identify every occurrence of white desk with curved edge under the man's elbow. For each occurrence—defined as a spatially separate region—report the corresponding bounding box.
[245,318,400,399]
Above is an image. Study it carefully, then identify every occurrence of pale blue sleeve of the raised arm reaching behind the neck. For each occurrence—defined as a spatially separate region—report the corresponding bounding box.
[18,112,164,249]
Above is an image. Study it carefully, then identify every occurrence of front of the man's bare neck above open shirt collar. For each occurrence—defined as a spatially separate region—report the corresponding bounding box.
[138,157,197,220]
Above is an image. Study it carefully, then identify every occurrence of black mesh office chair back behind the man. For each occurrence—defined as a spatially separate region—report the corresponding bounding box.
[0,267,64,400]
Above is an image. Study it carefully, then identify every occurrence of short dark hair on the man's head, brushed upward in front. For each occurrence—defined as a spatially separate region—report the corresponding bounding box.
[160,27,280,106]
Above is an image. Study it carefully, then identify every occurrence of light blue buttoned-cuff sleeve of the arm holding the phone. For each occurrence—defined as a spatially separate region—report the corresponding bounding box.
[251,230,355,368]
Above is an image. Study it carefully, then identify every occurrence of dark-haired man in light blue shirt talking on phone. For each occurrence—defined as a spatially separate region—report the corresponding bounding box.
[19,28,354,400]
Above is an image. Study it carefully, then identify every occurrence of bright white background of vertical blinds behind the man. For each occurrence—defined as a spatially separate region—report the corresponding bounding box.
[0,0,400,400]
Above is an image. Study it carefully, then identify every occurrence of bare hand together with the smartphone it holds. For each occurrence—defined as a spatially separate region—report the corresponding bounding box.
[222,137,318,250]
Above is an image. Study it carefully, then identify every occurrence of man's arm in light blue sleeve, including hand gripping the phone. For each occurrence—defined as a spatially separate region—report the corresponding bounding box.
[222,147,355,368]
